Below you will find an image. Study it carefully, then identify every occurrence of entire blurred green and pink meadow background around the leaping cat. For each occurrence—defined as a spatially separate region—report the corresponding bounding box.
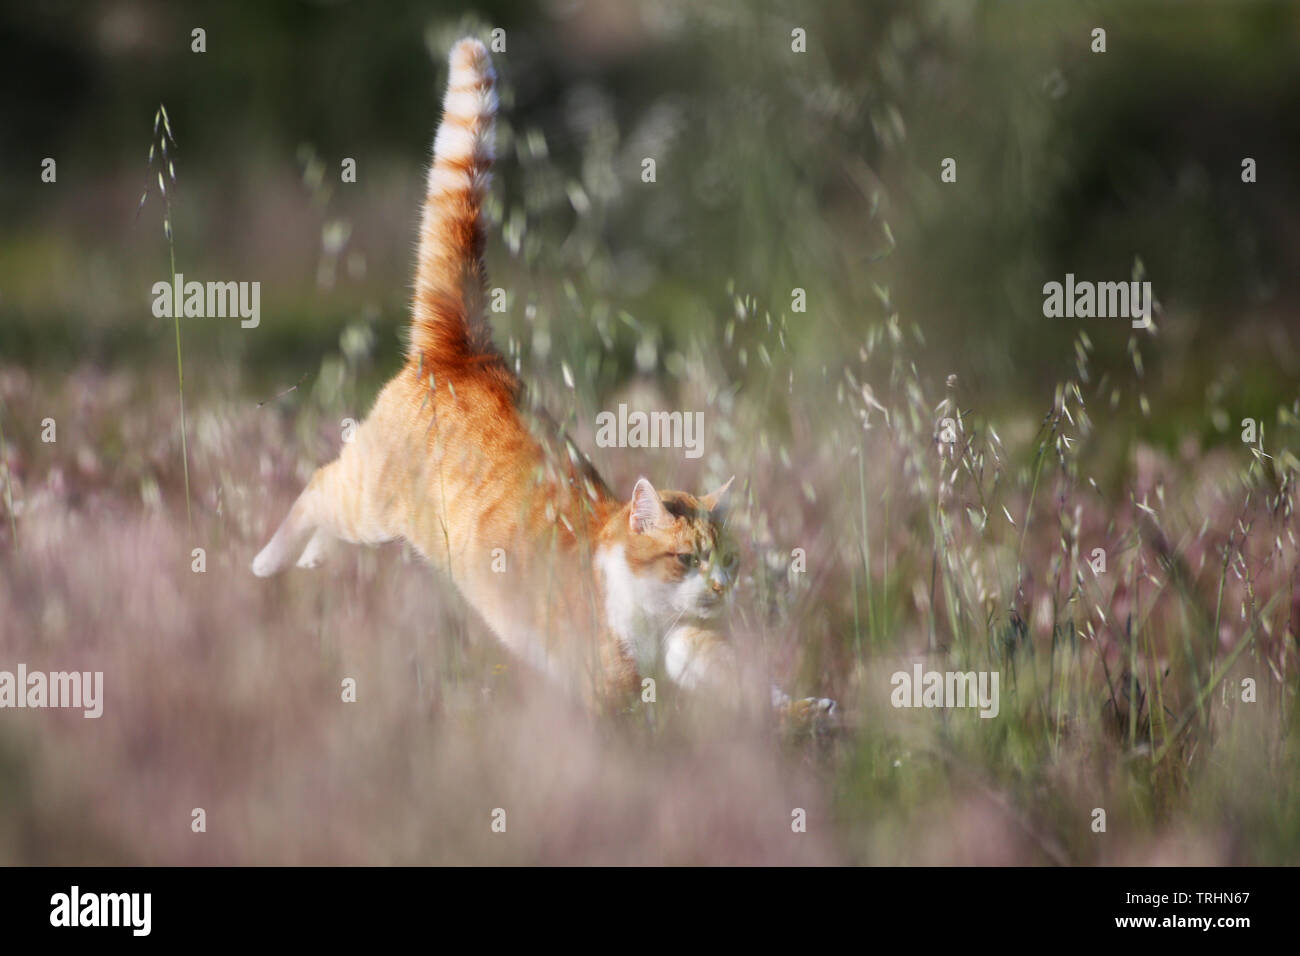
[0,0,1300,862]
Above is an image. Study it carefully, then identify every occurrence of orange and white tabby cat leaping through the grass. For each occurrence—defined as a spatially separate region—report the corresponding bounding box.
[252,39,833,711]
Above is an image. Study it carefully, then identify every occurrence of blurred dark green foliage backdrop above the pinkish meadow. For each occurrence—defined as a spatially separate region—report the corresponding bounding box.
[0,0,1300,437]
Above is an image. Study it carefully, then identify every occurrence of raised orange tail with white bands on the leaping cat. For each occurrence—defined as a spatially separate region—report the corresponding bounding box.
[410,38,497,368]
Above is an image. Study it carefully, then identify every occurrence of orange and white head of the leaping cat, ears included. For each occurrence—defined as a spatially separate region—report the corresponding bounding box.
[605,479,737,622]
